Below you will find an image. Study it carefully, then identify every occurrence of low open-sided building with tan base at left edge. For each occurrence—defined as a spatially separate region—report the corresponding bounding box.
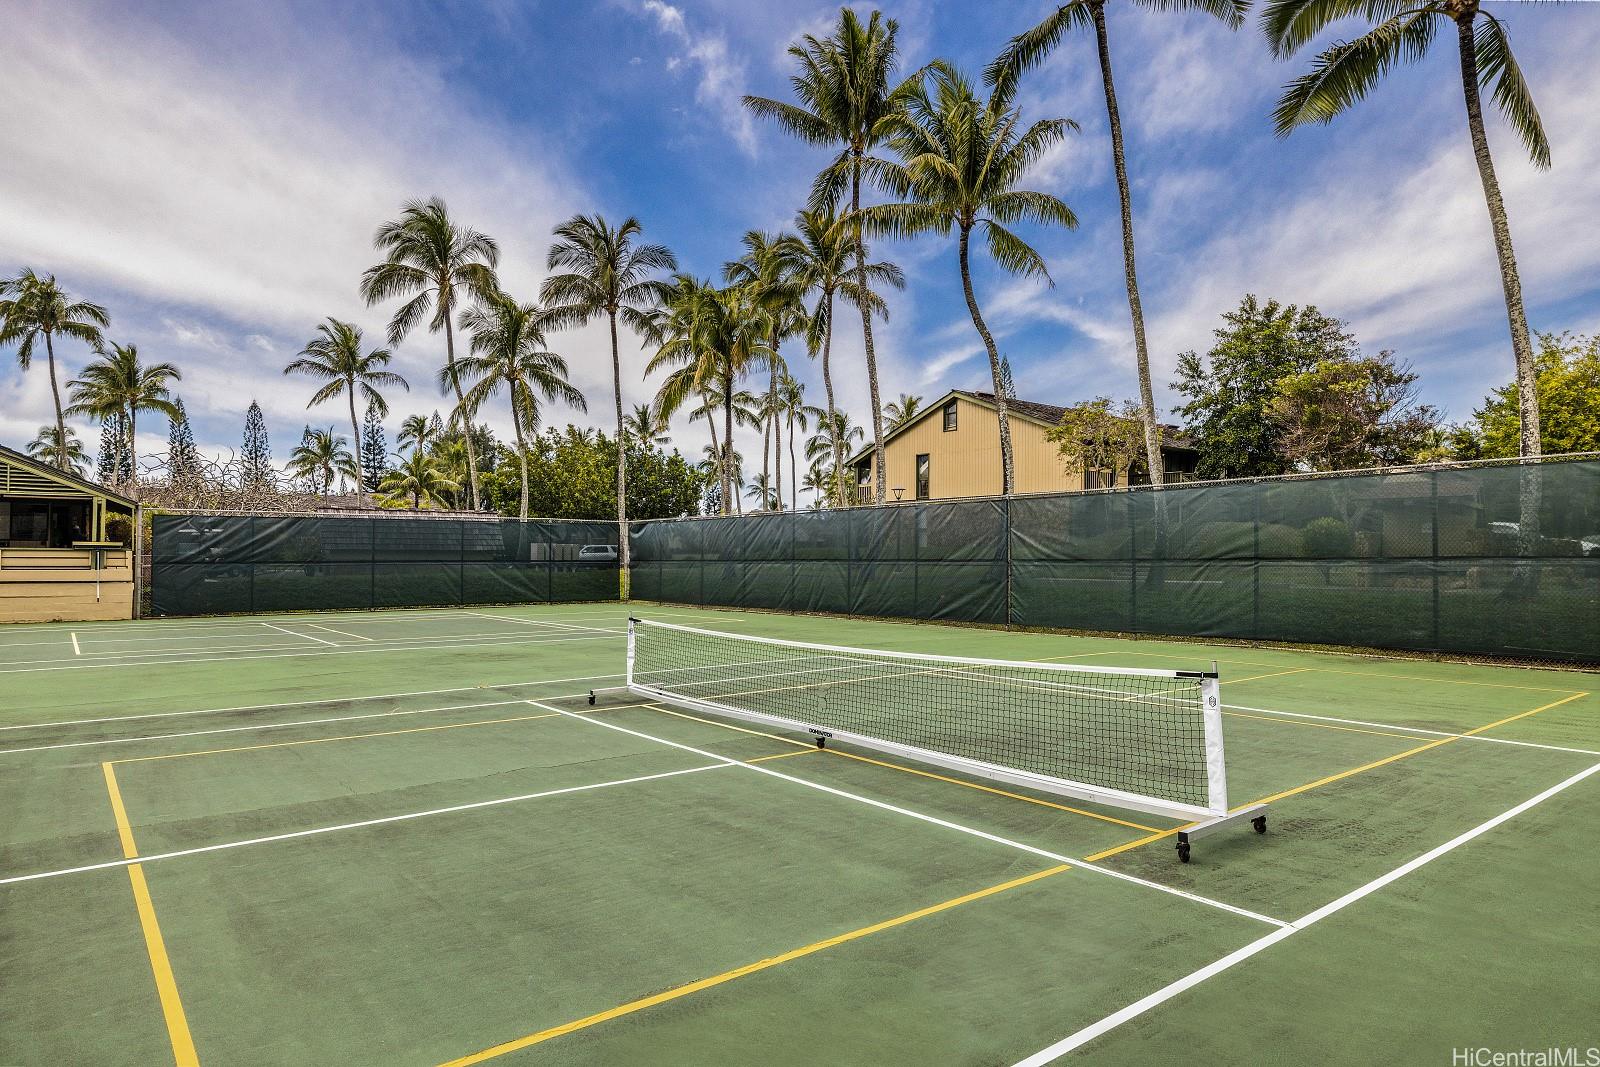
[0,445,134,622]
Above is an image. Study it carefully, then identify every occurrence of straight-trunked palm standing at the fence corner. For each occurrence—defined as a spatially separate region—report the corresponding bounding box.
[539,214,678,585]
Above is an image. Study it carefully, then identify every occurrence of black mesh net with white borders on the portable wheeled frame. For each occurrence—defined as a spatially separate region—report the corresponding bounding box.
[629,621,1210,808]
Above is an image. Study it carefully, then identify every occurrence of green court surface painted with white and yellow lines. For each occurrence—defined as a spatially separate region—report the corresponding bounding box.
[0,603,1600,1067]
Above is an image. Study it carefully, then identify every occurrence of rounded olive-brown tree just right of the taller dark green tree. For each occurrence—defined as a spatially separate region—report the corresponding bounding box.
[1267,352,1438,470]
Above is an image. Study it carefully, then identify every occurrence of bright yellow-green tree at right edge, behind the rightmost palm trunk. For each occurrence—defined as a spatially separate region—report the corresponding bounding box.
[1453,333,1600,459]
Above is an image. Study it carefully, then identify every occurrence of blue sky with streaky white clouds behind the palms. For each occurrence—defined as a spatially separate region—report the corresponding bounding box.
[0,0,1600,483]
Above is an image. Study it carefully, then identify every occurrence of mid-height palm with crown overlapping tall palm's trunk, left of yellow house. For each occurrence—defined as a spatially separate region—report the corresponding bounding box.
[787,210,906,508]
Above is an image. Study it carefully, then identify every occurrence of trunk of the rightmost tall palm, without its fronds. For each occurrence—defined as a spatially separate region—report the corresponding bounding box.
[1456,16,1542,559]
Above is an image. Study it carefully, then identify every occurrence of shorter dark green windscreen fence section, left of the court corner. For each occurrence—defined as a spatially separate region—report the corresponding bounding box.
[150,514,618,614]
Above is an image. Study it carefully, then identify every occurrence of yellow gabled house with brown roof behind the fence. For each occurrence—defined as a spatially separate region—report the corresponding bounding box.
[850,389,1198,502]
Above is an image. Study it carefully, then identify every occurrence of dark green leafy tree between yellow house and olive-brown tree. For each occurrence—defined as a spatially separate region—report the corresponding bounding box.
[1173,294,1357,478]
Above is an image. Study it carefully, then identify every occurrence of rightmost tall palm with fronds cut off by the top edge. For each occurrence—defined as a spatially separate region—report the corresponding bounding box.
[1261,0,1550,460]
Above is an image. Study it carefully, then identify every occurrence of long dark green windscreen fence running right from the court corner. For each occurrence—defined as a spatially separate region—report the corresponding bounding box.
[632,459,1600,662]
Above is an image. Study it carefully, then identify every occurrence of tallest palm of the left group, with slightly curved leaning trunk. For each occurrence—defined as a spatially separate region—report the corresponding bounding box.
[362,197,499,510]
